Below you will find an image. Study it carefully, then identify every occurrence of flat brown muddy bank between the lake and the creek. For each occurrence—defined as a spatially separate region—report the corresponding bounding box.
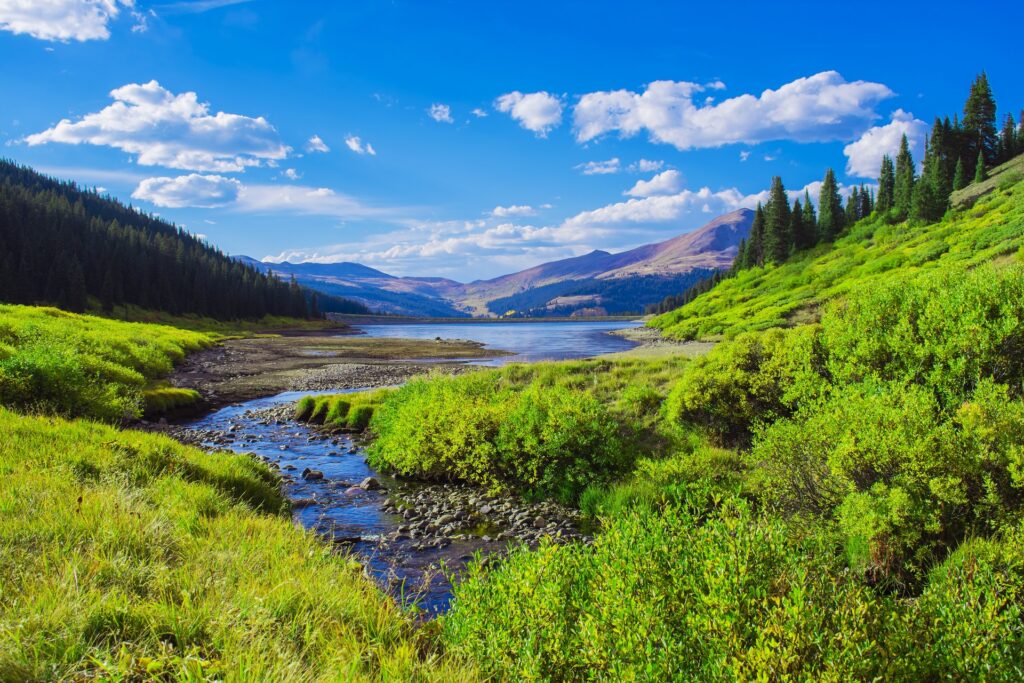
[164,334,505,417]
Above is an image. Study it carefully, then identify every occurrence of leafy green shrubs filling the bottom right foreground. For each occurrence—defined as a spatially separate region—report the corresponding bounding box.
[442,492,1024,681]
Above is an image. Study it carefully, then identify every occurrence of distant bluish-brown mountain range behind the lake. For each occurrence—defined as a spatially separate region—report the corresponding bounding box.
[239,209,754,316]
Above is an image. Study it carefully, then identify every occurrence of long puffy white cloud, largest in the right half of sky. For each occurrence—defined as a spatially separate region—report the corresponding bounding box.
[573,71,894,151]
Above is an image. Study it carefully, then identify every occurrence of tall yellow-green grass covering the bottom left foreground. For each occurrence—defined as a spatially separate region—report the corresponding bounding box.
[0,409,474,682]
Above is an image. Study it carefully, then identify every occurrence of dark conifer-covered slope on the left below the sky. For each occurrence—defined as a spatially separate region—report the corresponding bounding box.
[0,160,368,319]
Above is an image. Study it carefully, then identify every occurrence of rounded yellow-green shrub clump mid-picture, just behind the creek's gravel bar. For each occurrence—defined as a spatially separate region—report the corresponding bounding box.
[368,373,629,501]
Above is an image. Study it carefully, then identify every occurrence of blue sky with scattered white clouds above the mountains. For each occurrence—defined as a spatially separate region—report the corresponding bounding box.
[0,0,1024,281]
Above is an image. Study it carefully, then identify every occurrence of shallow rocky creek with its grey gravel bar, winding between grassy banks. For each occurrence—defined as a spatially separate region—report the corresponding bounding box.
[185,391,586,615]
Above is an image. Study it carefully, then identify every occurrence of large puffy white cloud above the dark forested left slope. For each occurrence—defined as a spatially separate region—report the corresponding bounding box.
[25,81,291,173]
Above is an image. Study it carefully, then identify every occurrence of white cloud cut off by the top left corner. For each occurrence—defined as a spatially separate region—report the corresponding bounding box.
[0,0,132,42]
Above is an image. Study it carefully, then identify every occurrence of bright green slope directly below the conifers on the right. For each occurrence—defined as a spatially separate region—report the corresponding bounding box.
[650,157,1024,339]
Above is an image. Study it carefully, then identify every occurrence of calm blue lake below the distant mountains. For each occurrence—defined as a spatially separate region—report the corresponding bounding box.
[357,321,641,366]
